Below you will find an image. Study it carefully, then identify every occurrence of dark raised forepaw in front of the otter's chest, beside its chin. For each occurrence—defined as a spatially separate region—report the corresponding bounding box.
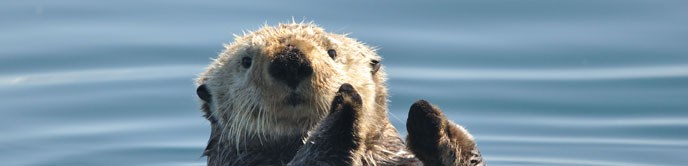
[289,84,363,165]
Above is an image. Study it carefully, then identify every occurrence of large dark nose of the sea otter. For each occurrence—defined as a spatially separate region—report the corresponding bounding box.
[268,46,313,89]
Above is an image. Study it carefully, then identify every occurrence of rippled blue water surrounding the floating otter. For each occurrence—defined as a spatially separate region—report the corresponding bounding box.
[0,0,688,166]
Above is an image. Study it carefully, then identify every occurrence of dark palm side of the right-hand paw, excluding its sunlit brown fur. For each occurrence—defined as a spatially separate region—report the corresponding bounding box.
[406,100,446,165]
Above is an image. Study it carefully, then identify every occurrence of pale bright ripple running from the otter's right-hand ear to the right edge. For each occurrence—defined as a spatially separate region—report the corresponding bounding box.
[388,65,688,81]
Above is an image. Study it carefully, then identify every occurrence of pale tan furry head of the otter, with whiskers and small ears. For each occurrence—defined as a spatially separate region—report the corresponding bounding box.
[197,23,387,151]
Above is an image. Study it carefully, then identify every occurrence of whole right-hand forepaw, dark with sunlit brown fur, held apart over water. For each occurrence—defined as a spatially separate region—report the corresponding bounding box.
[406,100,485,166]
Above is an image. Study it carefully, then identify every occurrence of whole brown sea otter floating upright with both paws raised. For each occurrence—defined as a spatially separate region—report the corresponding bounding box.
[196,23,484,166]
